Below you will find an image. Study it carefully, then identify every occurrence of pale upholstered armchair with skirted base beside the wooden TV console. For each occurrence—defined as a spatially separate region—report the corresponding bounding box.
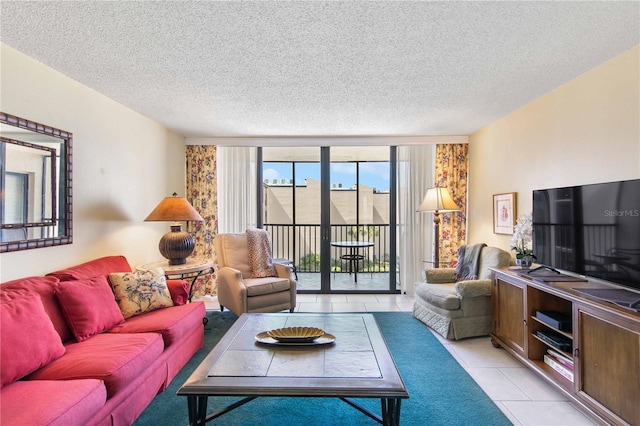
[413,246,511,340]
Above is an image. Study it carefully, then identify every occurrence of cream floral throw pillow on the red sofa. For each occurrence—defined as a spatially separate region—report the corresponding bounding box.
[109,268,173,319]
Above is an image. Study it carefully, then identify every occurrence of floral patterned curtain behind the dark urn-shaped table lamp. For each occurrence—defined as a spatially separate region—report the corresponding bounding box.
[186,145,218,296]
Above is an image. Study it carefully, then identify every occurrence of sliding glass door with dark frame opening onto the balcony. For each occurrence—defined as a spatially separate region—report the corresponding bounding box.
[261,147,397,293]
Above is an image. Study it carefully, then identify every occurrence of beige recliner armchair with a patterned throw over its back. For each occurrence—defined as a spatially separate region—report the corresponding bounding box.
[216,234,296,316]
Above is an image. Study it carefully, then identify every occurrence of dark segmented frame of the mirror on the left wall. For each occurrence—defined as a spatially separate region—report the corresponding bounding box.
[0,112,73,253]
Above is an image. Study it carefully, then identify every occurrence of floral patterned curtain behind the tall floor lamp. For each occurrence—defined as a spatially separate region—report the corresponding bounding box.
[435,144,469,266]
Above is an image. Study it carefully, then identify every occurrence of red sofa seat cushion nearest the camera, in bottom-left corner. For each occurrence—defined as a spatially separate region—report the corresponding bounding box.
[0,379,107,426]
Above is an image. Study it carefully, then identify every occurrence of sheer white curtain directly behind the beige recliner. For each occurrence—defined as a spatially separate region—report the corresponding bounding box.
[216,146,258,233]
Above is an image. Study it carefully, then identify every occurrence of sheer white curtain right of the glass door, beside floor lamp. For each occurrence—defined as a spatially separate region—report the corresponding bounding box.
[397,145,436,295]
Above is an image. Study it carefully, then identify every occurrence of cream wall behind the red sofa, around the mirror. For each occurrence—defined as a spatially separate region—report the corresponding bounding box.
[0,44,185,282]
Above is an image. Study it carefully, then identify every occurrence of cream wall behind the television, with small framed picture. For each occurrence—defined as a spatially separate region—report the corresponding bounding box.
[467,46,640,250]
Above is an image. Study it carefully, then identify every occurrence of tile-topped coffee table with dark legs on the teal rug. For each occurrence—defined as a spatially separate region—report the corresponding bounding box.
[178,313,409,425]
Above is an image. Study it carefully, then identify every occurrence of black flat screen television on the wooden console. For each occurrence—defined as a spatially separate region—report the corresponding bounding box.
[533,179,640,290]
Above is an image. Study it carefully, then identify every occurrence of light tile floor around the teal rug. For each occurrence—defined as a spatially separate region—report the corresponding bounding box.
[194,294,596,426]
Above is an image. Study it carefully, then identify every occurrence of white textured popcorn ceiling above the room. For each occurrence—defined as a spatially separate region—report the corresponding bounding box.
[0,0,640,137]
